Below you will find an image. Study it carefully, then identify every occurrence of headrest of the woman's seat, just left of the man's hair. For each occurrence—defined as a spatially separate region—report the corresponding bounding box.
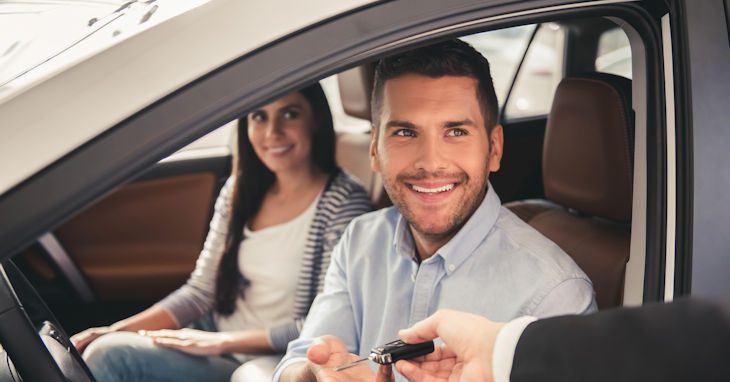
[337,63,375,121]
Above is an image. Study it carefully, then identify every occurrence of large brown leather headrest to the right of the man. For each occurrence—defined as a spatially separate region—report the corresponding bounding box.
[543,73,634,222]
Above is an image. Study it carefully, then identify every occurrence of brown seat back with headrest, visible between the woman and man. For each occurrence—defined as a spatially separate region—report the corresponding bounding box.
[337,64,391,209]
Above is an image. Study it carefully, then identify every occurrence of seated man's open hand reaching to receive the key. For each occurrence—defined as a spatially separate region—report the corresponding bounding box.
[307,336,394,382]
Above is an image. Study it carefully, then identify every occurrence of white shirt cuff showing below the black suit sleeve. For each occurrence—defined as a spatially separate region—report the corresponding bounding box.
[492,316,537,382]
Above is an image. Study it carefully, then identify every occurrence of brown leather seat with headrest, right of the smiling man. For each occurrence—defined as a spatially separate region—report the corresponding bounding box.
[505,73,634,309]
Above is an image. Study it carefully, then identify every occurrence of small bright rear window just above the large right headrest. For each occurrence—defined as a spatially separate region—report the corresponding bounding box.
[596,28,631,79]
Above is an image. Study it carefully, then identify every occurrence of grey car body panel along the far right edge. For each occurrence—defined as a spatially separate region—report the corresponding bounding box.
[677,0,730,296]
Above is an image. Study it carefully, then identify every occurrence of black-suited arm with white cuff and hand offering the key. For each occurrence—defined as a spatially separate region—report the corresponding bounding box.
[396,299,730,382]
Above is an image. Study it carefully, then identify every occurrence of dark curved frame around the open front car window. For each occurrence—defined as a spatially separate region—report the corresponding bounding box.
[0,0,666,302]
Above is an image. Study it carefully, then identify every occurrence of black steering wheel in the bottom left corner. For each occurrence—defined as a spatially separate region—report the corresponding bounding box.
[0,261,94,382]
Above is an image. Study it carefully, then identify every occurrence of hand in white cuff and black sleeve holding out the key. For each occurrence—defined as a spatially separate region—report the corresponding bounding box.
[395,310,504,382]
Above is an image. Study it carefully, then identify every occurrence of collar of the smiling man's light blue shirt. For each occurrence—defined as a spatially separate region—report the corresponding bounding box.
[393,184,502,274]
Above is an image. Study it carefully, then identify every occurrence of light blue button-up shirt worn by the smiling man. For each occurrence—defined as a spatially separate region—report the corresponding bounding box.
[274,186,596,380]
